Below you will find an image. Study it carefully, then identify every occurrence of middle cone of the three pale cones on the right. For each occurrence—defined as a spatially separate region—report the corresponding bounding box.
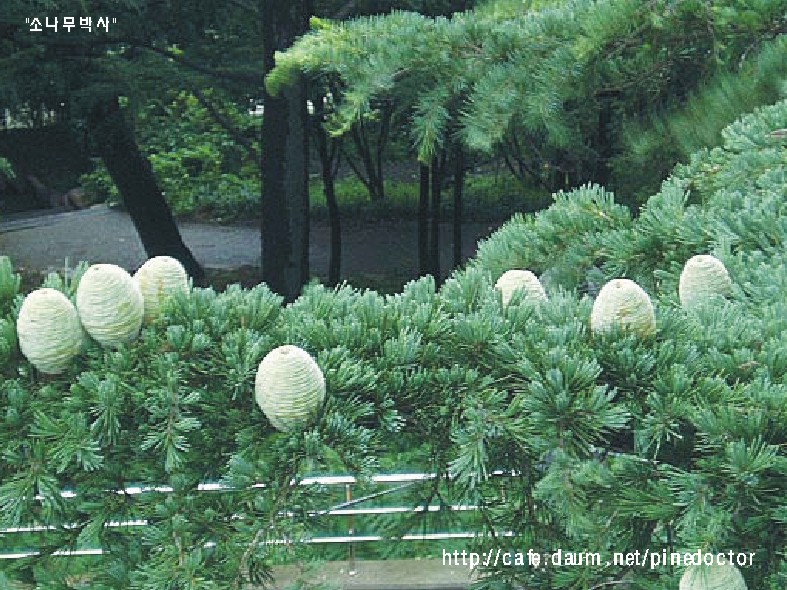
[590,279,656,336]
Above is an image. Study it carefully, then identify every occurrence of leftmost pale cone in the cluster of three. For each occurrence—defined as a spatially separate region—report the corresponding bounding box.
[16,289,82,375]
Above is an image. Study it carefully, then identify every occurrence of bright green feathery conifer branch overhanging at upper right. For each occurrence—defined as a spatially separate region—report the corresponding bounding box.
[266,0,785,192]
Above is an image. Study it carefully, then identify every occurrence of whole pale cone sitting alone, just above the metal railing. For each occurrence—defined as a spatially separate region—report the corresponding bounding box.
[255,345,325,432]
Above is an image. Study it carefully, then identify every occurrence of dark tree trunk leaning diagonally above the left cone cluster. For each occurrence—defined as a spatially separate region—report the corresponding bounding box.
[88,97,205,284]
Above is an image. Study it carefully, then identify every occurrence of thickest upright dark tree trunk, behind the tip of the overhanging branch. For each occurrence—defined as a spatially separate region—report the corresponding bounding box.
[260,0,309,301]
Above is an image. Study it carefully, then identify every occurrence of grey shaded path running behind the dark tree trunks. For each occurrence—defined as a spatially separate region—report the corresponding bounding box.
[0,205,499,290]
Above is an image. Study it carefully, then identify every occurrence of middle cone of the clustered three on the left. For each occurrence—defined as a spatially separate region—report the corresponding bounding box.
[77,264,144,347]
